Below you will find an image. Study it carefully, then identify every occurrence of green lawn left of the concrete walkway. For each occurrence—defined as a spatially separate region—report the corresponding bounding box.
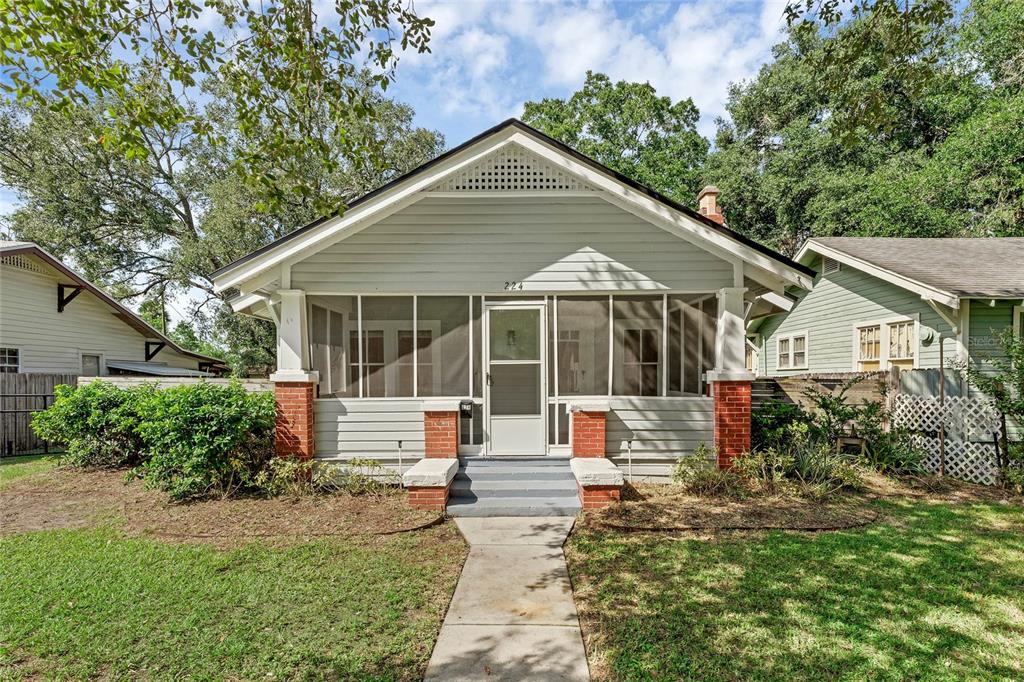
[0,527,454,680]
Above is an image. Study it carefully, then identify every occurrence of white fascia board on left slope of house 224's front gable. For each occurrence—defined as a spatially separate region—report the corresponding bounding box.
[214,129,524,292]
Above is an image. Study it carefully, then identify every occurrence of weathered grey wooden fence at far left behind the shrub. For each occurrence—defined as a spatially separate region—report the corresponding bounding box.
[0,374,78,457]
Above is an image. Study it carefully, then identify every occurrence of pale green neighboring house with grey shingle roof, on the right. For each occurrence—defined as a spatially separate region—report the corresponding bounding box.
[748,238,1024,376]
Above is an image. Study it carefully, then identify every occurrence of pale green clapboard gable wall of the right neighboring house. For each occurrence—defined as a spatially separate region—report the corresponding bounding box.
[759,265,956,376]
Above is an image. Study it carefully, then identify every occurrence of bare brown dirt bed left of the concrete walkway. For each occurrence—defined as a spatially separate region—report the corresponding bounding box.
[0,468,439,546]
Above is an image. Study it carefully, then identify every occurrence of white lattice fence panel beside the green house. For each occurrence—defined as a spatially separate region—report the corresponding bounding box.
[892,394,1000,485]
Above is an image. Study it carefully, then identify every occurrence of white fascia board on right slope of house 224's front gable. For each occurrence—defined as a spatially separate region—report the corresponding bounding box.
[512,131,813,289]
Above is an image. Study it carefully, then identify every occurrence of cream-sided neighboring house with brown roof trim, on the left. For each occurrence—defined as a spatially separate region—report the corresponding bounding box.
[0,241,225,377]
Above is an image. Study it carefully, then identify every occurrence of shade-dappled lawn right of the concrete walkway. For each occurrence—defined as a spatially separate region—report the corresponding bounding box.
[566,493,1024,680]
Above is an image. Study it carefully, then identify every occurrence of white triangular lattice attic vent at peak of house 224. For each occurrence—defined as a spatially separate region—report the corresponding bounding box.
[430,145,594,191]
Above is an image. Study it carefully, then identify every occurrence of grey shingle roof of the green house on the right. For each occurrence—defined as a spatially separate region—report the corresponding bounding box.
[809,237,1024,298]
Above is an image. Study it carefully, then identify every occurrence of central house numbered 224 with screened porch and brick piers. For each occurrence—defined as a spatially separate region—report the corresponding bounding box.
[213,120,813,507]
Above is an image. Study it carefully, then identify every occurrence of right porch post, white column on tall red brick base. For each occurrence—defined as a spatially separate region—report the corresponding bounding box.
[708,287,754,469]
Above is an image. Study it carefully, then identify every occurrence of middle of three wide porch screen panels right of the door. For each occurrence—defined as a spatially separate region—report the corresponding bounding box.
[611,294,666,395]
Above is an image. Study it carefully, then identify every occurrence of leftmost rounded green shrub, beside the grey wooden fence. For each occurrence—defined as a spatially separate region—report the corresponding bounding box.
[32,381,154,467]
